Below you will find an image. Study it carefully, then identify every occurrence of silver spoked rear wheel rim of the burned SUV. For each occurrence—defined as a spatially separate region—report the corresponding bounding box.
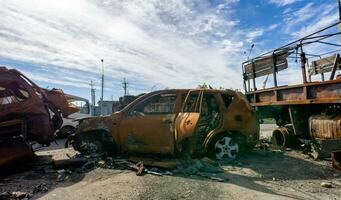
[214,136,239,160]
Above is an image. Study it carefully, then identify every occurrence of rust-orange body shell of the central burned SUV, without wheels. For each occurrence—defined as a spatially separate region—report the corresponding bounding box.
[74,89,259,157]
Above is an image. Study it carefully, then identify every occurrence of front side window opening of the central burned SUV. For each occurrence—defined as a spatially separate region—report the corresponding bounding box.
[130,94,177,115]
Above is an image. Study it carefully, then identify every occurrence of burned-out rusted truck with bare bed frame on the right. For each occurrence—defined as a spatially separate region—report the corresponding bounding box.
[242,22,341,156]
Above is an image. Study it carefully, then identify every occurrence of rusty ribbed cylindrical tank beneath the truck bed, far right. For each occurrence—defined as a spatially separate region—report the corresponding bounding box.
[309,115,341,139]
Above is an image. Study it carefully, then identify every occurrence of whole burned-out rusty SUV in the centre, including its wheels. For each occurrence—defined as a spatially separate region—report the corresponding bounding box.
[70,89,259,159]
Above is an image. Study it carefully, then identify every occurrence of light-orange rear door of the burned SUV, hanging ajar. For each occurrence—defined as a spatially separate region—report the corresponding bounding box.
[175,90,203,145]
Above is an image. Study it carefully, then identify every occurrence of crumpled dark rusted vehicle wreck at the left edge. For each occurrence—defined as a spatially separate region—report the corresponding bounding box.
[0,67,77,166]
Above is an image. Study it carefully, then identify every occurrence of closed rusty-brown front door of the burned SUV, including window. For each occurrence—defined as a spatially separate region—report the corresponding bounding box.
[120,92,178,154]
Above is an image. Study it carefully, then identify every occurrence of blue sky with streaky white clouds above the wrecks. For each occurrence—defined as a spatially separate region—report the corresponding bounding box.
[0,0,338,99]
